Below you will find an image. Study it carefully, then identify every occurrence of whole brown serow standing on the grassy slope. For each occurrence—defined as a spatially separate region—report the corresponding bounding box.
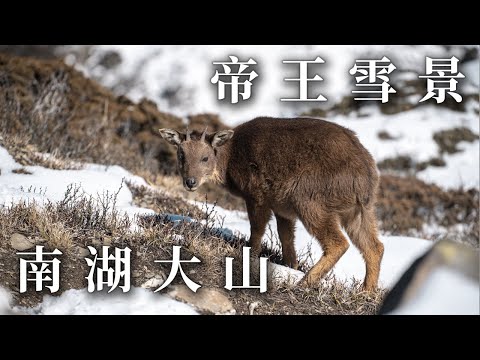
[160,117,383,290]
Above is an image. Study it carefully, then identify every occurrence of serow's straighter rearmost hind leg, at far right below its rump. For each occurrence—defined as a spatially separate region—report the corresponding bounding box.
[342,209,383,291]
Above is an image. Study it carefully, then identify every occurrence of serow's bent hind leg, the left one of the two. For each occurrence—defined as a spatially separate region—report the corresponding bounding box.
[300,206,349,286]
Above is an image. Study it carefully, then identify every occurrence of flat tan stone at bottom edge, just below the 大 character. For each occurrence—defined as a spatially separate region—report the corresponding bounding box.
[168,285,235,315]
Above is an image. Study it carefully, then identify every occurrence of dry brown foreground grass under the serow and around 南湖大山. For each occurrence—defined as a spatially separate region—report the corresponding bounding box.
[0,181,384,314]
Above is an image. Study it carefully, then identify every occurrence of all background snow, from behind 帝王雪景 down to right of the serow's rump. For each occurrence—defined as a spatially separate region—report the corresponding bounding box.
[72,45,480,188]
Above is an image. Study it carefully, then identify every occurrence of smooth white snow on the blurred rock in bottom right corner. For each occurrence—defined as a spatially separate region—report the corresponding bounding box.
[390,267,480,315]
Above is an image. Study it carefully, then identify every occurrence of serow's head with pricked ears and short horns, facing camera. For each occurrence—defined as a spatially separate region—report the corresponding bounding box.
[159,129,233,191]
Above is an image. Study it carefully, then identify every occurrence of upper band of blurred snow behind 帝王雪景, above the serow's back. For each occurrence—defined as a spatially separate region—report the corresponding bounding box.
[77,45,478,124]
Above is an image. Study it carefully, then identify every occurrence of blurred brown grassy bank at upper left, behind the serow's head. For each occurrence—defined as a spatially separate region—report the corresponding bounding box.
[0,54,182,177]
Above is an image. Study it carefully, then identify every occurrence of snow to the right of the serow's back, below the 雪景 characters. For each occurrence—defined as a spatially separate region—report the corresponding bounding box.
[330,105,480,189]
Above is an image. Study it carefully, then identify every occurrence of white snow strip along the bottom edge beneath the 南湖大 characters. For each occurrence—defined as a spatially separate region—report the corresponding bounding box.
[14,288,198,315]
